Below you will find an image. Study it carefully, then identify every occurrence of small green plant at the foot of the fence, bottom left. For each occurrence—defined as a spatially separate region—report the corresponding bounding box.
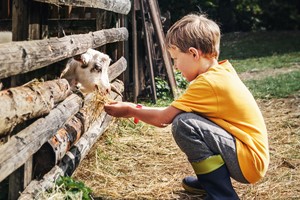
[56,176,92,200]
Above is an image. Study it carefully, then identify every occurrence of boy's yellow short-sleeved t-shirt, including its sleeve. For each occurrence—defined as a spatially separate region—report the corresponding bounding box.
[171,60,270,183]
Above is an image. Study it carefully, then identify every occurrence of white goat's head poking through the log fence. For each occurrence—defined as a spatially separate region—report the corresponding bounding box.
[60,49,120,94]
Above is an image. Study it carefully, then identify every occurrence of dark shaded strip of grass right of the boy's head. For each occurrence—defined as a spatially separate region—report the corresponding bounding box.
[220,31,300,59]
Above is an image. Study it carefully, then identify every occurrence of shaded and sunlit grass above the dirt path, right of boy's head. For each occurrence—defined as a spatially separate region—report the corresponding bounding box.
[220,31,300,73]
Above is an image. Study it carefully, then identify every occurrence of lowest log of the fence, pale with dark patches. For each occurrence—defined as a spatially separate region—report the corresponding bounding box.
[19,82,122,200]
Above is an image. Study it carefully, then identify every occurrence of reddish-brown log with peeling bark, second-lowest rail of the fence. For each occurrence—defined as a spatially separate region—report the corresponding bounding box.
[34,81,124,177]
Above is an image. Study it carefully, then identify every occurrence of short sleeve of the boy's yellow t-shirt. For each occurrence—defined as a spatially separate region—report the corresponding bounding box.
[171,78,218,116]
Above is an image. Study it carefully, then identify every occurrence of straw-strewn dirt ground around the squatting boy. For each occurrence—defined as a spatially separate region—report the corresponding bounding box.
[74,71,300,200]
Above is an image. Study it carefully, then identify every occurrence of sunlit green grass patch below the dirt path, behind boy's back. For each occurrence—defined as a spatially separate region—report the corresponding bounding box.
[245,71,300,99]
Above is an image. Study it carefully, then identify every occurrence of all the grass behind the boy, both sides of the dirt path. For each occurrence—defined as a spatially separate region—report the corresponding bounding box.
[220,31,300,99]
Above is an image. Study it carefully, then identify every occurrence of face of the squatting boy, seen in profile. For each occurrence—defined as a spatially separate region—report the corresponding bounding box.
[168,46,200,82]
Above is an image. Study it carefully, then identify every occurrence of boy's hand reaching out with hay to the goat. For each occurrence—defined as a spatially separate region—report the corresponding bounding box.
[104,102,136,118]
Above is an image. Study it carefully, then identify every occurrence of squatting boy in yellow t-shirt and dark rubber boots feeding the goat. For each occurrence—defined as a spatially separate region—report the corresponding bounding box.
[105,14,269,199]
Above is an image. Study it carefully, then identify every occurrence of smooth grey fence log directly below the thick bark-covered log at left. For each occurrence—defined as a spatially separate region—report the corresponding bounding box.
[0,94,83,182]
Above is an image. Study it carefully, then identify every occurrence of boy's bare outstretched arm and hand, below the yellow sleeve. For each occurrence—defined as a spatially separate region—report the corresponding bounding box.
[104,102,182,127]
